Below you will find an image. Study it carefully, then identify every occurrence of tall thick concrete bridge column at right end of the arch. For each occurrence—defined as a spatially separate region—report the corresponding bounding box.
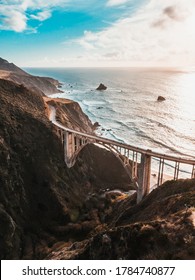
[137,154,151,203]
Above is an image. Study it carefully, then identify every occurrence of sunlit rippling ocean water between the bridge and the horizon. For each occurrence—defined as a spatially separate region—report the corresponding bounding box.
[26,68,195,158]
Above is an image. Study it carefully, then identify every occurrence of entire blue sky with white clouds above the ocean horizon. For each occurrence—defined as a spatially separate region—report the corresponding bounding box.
[0,0,195,67]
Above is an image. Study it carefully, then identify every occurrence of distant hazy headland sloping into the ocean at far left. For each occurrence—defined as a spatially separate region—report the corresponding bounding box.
[0,58,61,95]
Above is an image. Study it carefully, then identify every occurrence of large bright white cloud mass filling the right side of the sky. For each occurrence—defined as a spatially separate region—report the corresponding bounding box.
[75,0,195,66]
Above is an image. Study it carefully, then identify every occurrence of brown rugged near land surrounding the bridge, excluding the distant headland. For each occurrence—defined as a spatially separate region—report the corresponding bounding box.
[0,63,195,260]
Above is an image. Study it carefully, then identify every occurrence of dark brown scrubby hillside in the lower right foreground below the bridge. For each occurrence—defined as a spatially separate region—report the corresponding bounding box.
[47,179,195,260]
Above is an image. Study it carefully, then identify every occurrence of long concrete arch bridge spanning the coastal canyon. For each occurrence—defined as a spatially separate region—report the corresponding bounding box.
[49,105,195,203]
